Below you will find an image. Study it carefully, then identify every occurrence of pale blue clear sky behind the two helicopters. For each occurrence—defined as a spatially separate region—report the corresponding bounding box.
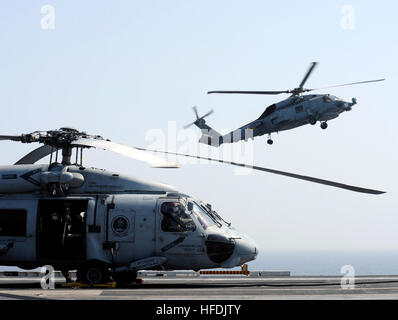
[0,0,398,254]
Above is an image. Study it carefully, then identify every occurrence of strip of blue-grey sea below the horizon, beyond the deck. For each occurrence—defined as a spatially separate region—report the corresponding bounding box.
[0,250,398,276]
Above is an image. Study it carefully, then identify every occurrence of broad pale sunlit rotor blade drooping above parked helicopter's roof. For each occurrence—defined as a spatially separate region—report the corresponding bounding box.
[71,138,179,168]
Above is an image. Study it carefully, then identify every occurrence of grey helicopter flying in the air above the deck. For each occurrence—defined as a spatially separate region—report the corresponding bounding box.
[185,62,385,147]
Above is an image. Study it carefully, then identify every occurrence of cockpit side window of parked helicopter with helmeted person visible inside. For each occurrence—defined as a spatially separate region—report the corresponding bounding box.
[161,202,196,232]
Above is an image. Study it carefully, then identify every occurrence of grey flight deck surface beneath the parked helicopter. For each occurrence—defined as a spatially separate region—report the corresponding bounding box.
[0,275,398,300]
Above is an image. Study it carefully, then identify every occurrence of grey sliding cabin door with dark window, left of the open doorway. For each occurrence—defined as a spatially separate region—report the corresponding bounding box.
[0,199,37,265]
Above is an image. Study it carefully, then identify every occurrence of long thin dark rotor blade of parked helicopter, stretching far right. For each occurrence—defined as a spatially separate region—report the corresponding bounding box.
[138,148,385,194]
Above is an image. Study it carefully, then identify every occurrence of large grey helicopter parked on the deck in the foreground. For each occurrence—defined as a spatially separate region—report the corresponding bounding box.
[0,127,384,284]
